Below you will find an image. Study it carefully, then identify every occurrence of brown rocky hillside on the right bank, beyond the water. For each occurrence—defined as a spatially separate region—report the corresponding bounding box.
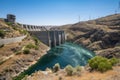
[59,14,120,58]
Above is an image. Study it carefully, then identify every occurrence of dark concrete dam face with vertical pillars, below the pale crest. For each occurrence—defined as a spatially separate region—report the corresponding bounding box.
[29,31,65,47]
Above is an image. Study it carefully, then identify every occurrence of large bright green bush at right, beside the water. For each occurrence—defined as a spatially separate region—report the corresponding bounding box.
[88,56,112,72]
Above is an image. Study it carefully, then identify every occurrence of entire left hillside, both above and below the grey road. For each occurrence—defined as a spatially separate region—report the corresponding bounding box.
[0,20,49,80]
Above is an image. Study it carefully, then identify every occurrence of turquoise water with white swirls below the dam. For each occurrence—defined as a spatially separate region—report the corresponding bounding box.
[25,43,95,75]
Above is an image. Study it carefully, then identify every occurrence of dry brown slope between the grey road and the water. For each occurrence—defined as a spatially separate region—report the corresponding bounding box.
[0,39,50,80]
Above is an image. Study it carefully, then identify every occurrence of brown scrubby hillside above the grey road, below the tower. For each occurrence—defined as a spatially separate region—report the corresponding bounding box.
[0,19,25,38]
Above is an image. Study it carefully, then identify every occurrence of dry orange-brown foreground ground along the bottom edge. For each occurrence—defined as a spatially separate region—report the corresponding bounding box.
[26,66,120,80]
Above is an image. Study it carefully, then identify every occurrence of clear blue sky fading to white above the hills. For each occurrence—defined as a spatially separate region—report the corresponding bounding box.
[0,0,120,25]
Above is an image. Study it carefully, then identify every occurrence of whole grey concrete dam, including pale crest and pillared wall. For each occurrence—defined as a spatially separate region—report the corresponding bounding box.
[21,24,65,47]
